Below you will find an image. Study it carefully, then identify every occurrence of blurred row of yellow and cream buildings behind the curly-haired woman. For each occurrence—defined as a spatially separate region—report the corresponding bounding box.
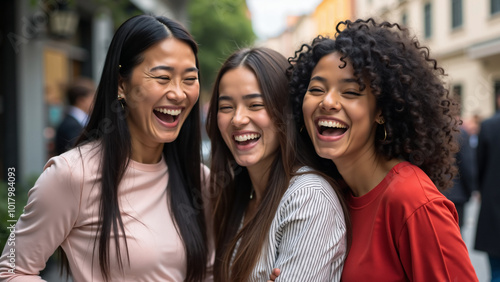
[259,0,500,119]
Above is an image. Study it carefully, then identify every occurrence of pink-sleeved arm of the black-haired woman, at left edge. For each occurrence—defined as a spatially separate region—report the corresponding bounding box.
[0,157,79,281]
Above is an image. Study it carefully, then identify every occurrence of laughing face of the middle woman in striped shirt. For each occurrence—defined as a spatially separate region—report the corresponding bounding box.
[217,67,278,170]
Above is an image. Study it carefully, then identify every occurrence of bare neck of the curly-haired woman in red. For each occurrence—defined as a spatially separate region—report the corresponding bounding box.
[335,148,401,197]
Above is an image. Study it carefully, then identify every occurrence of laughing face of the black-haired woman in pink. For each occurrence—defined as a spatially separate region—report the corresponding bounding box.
[118,38,200,150]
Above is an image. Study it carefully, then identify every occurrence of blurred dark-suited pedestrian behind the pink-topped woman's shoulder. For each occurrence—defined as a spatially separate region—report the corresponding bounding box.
[55,77,95,155]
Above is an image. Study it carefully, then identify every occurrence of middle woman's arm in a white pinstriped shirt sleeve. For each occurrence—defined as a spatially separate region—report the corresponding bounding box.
[273,180,346,282]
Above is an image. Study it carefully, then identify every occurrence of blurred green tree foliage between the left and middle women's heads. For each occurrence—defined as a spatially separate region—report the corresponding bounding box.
[188,0,256,95]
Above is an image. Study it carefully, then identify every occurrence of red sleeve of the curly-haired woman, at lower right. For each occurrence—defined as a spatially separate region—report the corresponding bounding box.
[397,198,478,281]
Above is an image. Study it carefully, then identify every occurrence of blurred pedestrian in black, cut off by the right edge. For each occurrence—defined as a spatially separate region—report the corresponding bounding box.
[475,92,500,281]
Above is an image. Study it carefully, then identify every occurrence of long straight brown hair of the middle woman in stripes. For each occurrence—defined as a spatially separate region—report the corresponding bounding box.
[207,48,295,281]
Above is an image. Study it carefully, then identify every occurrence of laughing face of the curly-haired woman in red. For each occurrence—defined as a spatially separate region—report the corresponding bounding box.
[302,52,380,166]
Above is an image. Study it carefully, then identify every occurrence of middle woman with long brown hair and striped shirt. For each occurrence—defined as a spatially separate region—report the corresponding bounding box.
[207,48,346,281]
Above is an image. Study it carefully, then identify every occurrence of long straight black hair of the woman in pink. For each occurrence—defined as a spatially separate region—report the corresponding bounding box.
[77,15,208,281]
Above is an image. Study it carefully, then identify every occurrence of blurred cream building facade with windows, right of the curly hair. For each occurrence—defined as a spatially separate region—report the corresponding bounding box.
[355,0,500,118]
